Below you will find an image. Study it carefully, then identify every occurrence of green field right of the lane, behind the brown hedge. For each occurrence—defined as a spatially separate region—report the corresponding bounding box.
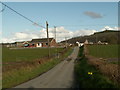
[87,45,120,58]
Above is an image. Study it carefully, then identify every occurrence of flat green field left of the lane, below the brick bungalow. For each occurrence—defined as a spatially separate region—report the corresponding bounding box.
[2,47,63,62]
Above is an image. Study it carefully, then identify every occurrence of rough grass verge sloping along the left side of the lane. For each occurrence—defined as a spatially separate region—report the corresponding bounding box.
[2,48,72,88]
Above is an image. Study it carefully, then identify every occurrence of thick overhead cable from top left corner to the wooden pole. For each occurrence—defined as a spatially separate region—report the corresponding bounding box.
[0,1,45,28]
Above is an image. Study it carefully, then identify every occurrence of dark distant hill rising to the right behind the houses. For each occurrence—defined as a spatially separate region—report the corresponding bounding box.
[61,30,120,44]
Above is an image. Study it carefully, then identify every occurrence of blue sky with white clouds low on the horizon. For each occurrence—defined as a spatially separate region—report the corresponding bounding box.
[0,2,118,42]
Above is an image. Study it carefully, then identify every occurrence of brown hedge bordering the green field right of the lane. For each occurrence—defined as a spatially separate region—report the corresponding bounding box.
[84,46,120,87]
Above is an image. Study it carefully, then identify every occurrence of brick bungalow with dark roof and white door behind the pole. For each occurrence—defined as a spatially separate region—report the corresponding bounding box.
[30,38,57,47]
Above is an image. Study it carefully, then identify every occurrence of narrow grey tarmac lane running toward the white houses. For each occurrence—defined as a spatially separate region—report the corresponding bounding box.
[14,47,79,88]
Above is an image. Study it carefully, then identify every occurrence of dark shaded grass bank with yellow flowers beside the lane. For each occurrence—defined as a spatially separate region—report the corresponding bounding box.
[75,47,117,88]
